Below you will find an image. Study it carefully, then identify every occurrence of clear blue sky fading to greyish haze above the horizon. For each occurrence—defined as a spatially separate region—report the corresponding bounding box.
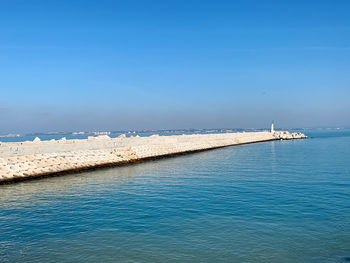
[0,0,350,133]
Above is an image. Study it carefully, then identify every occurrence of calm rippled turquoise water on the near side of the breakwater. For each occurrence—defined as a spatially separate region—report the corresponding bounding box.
[0,131,350,263]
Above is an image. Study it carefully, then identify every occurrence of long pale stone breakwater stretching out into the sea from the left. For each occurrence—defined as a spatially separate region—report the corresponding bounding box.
[0,131,306,183]
